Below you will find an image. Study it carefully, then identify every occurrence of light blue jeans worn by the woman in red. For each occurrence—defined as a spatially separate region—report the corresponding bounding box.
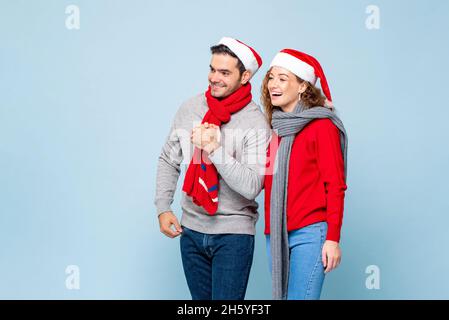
[266,222,327,300]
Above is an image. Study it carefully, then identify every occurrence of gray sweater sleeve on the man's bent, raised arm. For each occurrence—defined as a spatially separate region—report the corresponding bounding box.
[209,125,271,200]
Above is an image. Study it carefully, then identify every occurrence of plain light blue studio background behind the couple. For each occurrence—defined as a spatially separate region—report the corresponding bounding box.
[0,0,449,299]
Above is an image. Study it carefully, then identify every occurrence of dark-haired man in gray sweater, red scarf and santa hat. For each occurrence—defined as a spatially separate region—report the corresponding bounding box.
[155,37,270,300]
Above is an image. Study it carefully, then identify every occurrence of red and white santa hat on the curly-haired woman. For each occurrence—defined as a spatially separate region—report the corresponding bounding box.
[270,49,333,107]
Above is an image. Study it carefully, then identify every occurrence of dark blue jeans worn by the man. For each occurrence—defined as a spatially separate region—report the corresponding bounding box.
[180,226,254,300]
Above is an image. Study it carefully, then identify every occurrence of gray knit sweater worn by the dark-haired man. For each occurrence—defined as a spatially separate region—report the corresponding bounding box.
[155,94,271,234]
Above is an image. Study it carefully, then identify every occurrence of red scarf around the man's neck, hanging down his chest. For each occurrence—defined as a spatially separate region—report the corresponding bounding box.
[182,82,252,215]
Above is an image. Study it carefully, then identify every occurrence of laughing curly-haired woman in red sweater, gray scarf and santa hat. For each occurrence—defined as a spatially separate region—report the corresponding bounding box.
[262,49,347,299]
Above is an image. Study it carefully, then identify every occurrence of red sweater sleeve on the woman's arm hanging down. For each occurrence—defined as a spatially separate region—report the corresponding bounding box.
[316,119,347,242]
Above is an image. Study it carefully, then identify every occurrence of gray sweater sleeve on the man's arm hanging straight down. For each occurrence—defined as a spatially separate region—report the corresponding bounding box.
[154,111,183,215]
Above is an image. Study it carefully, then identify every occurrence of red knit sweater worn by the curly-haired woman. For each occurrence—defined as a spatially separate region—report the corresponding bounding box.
[265,119,347,242]
